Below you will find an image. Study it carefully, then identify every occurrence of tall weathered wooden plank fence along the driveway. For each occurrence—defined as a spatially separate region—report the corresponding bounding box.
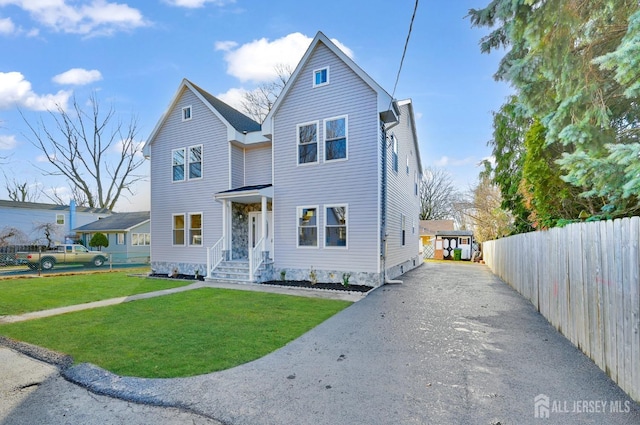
[482,217,640,402]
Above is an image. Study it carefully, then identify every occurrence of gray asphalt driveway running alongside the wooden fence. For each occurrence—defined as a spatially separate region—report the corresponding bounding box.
[0,262,640,425]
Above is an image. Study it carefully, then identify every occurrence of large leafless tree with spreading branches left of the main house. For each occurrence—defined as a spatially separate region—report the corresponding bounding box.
[21,94,144,209]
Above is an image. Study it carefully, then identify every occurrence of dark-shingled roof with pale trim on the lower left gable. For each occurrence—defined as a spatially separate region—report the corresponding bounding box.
[142,78,260,158]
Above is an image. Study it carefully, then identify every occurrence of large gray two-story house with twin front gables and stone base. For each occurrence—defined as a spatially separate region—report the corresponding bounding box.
[144,33,422,286]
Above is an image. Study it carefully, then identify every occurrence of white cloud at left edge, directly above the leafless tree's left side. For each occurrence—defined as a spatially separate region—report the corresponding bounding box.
[0,72,71,111]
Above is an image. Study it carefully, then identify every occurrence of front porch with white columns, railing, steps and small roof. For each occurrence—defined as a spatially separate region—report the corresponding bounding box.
[206,184,273,283]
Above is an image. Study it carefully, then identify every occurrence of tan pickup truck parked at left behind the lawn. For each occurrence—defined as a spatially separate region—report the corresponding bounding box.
[16,244,107,270]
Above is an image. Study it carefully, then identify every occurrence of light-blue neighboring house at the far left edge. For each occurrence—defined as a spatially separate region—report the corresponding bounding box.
[0,200,112,245]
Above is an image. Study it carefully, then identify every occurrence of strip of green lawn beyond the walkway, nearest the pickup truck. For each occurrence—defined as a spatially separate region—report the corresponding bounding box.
[0,269,193,316]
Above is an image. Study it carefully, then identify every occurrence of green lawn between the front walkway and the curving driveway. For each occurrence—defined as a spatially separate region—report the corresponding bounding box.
[0,288,351,378]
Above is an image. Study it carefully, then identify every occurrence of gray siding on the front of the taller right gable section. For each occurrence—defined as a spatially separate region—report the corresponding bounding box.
[273,43,379,272]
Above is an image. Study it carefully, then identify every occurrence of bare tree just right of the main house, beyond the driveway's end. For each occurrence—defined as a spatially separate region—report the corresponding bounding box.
[420,167,459,220]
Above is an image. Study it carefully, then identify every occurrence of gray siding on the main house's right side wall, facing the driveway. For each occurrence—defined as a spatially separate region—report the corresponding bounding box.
[386,105,421,268]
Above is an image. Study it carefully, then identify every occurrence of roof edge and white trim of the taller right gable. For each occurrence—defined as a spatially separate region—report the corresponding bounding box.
[262,31,399,135]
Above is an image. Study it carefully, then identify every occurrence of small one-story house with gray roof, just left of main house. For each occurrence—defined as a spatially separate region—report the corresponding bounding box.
[75,211,151,263]
